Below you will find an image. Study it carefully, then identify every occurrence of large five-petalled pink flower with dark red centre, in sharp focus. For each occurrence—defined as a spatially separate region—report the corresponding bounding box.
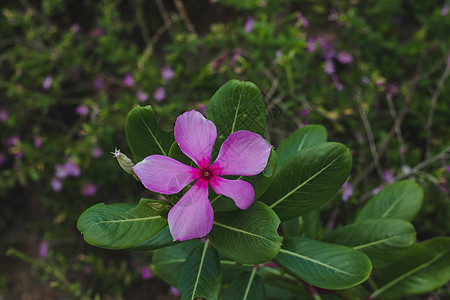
[133,111,272,241]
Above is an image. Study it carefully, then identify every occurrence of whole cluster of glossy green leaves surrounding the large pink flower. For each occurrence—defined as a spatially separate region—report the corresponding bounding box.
[78,80,450,299]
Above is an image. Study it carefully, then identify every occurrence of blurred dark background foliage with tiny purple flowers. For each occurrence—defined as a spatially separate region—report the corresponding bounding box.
[0,0,450,299]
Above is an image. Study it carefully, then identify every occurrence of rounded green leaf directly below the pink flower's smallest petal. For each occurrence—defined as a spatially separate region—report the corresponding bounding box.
[209,201,283,264]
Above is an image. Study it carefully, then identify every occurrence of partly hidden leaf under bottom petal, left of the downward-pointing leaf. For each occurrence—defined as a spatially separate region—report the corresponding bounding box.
[152,240,203,286]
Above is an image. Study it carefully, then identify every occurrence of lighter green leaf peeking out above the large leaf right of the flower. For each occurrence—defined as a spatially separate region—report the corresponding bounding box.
[277,125,327,167]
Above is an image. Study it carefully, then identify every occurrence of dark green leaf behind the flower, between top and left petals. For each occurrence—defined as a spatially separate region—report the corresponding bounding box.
[125,105,175,162]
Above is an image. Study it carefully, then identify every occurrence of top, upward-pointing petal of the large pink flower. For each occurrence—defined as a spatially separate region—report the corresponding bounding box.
[175,110,217,169]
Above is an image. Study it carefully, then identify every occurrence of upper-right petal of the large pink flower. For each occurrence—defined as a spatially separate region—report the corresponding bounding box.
[211,130,272,176]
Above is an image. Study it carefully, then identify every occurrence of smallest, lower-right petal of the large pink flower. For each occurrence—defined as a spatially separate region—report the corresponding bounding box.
[209,176,255,209]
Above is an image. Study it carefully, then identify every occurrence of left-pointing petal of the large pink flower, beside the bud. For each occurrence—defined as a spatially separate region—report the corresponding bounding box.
[133,155,199,194]
